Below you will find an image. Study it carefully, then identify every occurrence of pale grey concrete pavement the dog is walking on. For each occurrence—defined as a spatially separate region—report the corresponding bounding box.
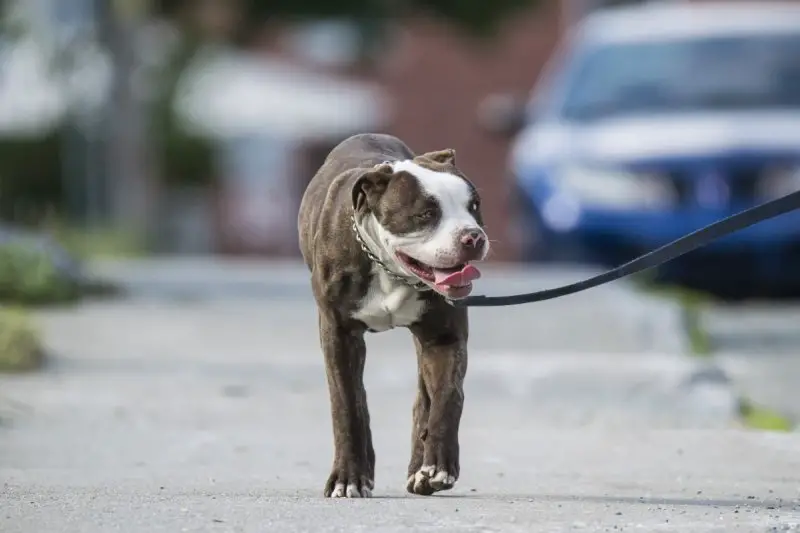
[0,265,800,533]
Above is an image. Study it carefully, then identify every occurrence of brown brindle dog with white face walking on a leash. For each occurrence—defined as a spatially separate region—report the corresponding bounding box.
[298,133,490,498]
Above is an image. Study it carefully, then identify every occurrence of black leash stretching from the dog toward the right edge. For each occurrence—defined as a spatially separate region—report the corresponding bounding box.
[451,191,800,307]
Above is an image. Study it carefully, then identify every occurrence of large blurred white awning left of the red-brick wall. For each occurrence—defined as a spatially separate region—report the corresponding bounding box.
[175,46,389,139]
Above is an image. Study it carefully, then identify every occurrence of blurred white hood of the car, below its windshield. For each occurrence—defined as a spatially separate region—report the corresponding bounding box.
[511,111,800,166]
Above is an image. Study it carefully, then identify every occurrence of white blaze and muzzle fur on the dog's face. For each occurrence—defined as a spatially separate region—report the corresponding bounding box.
[382,161,489,268]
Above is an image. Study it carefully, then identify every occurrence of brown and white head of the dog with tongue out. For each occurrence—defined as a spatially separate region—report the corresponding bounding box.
[353,150,489,299]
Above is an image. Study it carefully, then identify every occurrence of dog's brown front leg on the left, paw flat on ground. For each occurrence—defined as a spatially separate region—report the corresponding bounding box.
[319,311,375,498]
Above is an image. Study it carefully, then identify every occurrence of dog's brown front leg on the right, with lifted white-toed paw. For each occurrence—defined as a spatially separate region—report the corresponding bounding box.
[406,312,467,496]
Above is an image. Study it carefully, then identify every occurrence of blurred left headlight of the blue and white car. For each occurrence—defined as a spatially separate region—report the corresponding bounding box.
[554,165,677,208]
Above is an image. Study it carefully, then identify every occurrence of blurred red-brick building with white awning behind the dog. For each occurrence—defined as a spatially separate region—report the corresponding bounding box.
[145,2,565,260]
